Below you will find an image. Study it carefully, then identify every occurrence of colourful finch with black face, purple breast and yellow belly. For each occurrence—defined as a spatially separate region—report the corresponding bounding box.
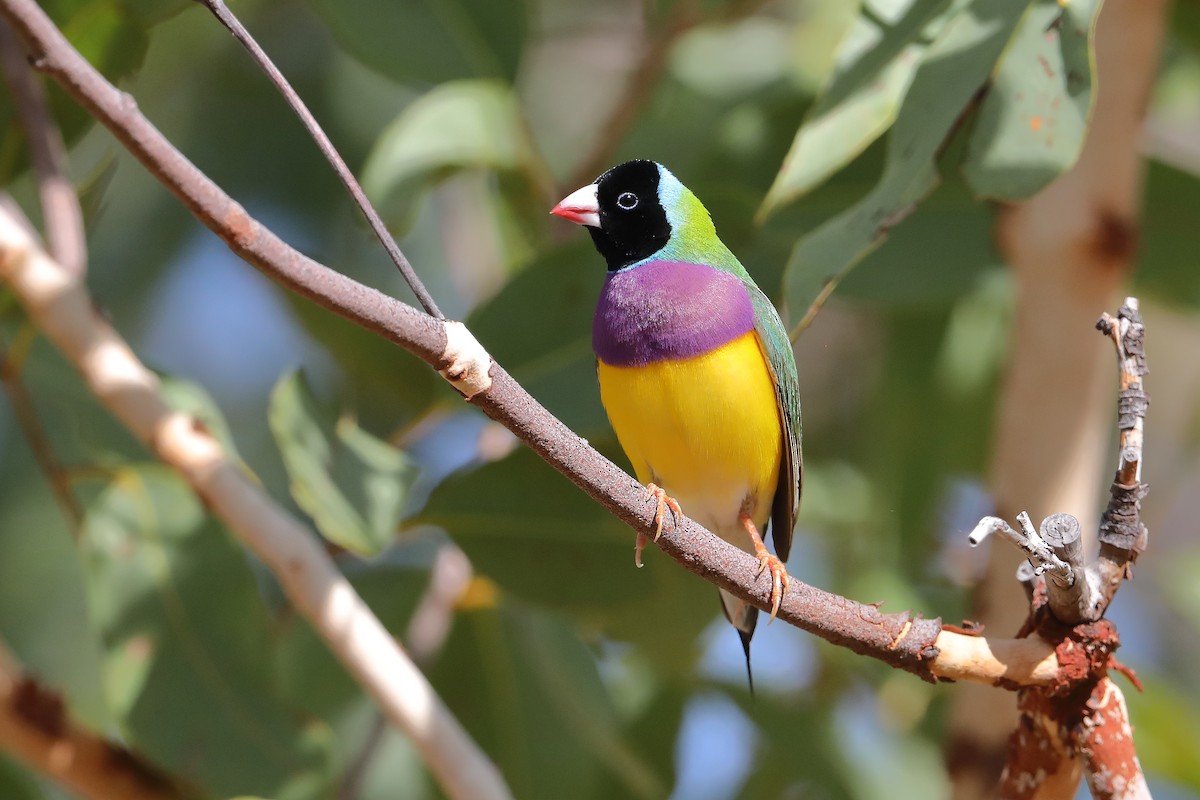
[551,160,803,692]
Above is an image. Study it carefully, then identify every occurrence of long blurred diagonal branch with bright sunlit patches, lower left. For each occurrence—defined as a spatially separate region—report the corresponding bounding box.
[0,210,510,800]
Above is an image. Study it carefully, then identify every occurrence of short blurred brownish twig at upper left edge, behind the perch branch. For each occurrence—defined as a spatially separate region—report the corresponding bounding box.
[0,22,88,273]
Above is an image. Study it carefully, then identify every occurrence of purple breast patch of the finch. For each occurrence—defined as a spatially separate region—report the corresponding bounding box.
[592,261,754,367]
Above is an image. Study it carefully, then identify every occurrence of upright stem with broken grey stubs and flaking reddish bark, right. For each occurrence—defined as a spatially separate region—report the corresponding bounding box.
[992,297,1150,800]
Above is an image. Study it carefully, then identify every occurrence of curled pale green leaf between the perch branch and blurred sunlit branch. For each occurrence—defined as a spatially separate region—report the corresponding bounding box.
[268,372,416,555]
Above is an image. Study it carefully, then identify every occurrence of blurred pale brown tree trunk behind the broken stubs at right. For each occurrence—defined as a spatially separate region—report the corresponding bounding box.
[949,0,1168,800]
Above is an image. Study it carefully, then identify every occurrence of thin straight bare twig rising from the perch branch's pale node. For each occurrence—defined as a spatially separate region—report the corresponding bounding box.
[200,0,445,319]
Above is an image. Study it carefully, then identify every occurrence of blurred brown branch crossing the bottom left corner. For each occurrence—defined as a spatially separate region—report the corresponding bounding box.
[0,646,182,800]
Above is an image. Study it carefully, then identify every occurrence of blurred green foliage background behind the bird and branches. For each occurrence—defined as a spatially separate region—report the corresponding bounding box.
[0,0,1200,800]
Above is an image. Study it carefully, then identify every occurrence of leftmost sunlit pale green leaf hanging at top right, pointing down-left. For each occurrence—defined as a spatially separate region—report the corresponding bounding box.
[758,0,962,217]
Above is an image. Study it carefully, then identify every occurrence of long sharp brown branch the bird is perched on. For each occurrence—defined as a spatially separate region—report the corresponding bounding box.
[0,0,1057,688]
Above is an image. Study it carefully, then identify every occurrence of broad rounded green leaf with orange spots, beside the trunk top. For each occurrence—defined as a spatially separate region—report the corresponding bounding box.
[962,0,1102,201]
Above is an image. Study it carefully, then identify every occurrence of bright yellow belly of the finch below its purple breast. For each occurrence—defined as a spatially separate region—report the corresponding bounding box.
[598,331,784,547]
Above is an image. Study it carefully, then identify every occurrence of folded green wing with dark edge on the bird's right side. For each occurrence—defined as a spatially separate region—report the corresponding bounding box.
[744,283,804,561]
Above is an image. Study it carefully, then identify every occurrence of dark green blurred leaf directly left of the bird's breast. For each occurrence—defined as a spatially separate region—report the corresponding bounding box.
[467,241,611,437]
